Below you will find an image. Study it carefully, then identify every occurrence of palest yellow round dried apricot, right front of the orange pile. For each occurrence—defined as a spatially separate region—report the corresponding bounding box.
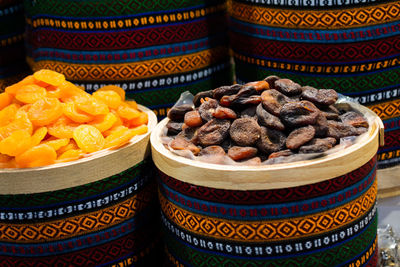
[72,124,105,153]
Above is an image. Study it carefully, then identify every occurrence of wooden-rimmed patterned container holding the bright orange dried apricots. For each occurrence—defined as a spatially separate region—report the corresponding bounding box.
[0,106,159,266]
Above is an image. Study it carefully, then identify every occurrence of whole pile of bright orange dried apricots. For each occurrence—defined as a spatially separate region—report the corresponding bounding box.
[0,69,148,168]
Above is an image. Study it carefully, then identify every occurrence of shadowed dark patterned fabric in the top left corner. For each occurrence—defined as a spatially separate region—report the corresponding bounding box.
[0,0,29,91]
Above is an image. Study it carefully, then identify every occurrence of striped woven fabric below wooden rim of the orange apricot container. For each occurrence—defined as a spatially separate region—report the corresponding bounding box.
[0,160,160,266]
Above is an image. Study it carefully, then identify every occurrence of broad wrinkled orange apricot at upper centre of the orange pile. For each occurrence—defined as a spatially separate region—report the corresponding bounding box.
[28,97,63,126]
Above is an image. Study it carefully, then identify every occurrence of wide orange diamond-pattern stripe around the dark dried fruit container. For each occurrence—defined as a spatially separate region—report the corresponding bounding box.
[159,180,377,242]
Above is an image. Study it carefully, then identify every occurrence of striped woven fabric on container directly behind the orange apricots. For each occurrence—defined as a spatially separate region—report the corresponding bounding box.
[24,0,233,117]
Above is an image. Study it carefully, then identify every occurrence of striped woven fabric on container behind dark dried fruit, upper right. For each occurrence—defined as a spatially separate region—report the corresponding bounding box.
[229,0,400,168]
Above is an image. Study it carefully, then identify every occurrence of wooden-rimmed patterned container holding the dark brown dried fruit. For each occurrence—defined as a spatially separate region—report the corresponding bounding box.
[150,105,383,267]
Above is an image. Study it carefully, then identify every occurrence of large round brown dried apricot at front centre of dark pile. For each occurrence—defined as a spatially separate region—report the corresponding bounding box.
[229,118,261,146]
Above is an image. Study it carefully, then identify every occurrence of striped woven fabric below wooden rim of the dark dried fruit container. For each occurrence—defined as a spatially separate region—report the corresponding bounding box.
[159,157,377,266]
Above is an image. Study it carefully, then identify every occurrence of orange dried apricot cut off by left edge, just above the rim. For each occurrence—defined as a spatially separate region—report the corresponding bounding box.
[0,130,31,156]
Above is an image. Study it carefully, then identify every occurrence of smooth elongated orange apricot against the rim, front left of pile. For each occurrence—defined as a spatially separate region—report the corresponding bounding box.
[15,144,57,168]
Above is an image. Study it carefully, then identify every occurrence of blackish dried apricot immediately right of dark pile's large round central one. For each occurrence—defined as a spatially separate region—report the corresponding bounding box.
[257,127,286,154]
